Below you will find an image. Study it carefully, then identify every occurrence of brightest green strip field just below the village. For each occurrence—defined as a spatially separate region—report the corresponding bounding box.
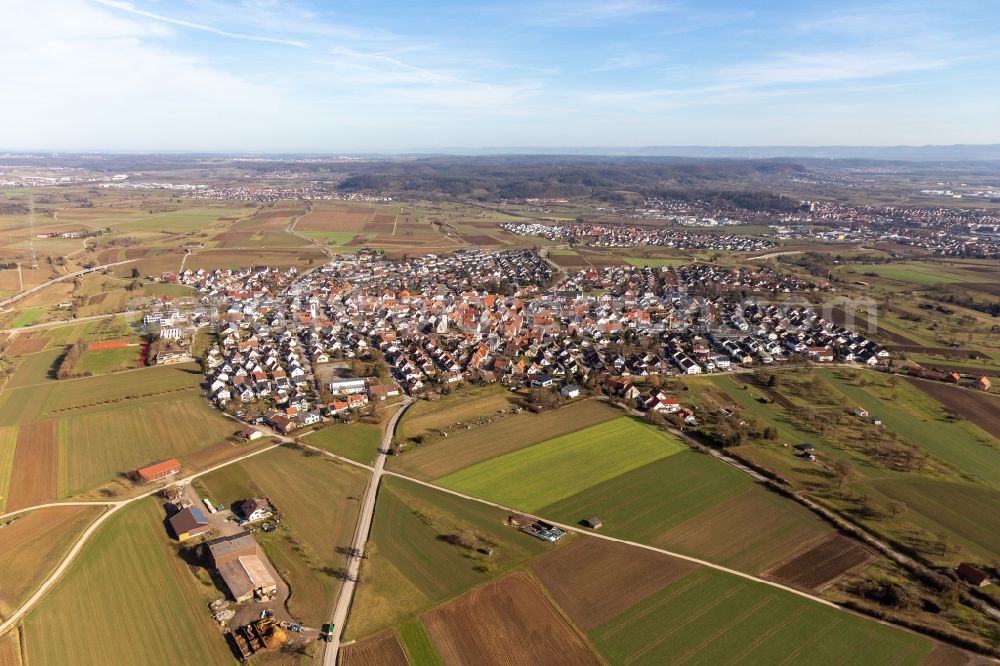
[437,417,685,511]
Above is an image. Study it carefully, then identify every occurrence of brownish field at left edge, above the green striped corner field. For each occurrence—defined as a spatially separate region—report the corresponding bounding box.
[0,506,102,616]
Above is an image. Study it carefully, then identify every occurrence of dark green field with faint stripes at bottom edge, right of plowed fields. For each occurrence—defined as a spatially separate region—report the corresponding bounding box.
[588,569,934,665]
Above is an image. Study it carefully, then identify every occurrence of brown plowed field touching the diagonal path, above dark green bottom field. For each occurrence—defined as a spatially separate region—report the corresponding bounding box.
[531,538,698,631]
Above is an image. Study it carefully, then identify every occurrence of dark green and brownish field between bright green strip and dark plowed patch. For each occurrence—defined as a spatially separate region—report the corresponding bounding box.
[538,450,831,573]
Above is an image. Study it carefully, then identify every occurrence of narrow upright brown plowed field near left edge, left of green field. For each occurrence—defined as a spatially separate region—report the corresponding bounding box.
[7,421,59,511]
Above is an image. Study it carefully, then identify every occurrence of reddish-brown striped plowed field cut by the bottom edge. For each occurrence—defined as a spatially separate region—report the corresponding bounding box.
[423,573,600,666]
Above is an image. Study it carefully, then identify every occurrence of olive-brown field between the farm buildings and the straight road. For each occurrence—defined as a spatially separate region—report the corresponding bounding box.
[196,446,367,626]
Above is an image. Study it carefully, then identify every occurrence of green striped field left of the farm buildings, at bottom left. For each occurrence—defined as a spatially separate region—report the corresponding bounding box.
[24,499,234,666]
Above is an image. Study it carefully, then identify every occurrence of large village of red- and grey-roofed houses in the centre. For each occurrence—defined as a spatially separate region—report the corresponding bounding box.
[186,251,889,404]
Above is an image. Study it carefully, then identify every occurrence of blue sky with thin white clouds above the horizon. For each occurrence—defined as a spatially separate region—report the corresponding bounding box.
[0,0,1000,152]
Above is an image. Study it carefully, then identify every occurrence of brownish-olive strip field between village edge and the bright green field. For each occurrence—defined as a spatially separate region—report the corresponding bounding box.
[389,400,622,480]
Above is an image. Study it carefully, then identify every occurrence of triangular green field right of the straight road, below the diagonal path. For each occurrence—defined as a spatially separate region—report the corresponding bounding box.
[347,477,552,640]
